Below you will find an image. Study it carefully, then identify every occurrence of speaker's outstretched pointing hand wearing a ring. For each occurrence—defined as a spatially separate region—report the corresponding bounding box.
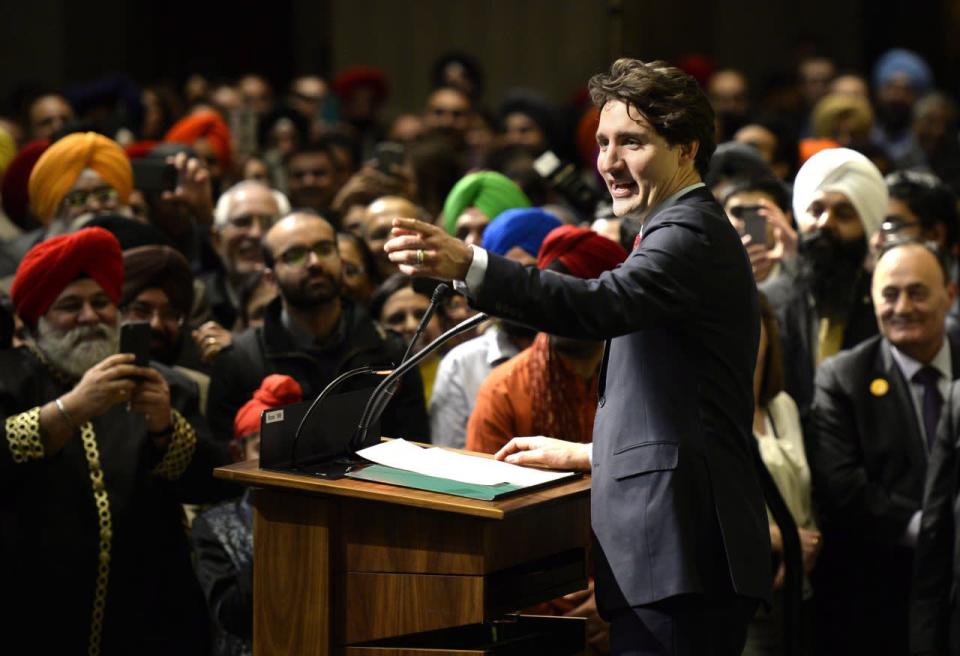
[383,218,473,280]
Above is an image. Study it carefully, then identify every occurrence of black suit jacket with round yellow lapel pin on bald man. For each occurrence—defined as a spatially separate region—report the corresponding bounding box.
[805,336,960,654]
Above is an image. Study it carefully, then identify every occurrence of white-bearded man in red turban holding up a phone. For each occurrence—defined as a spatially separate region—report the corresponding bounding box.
[0,228,231,654]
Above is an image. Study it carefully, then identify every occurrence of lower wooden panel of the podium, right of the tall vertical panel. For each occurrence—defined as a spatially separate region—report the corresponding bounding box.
[344,572,484,644]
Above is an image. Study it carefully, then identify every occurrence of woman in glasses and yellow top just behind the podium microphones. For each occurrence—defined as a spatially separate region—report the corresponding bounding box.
[370,273,444,407]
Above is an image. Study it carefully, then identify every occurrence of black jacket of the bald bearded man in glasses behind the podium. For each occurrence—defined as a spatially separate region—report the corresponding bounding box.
[207,298,430,442]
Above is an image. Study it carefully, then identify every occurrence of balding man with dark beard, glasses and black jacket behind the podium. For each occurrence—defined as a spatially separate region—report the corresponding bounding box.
[207,211,430,441]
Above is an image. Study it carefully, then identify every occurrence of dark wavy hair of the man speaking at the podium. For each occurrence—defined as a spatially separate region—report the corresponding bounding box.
[588,57,717,177]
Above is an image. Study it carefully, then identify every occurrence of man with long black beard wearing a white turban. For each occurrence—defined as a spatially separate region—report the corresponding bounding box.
[767,148,887,417]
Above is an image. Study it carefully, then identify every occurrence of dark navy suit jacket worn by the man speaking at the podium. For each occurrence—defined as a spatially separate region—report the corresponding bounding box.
[473,188,771,614]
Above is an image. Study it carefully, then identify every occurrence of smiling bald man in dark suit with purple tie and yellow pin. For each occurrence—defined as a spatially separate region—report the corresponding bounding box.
[806,242,960,656]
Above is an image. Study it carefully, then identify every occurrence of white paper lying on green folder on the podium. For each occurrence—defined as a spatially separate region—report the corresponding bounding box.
[357,439,574,487]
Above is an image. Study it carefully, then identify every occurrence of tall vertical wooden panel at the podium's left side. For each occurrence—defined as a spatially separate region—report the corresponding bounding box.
[253,489,336,656]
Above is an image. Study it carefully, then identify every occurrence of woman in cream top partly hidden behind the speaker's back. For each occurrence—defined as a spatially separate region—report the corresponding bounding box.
[743,294,821,656]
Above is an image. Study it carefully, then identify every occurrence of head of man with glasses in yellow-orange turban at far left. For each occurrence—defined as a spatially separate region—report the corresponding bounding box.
[27,132,133,231]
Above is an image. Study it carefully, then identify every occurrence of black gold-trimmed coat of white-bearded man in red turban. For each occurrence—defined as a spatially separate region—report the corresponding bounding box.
[0,349,236,655]
